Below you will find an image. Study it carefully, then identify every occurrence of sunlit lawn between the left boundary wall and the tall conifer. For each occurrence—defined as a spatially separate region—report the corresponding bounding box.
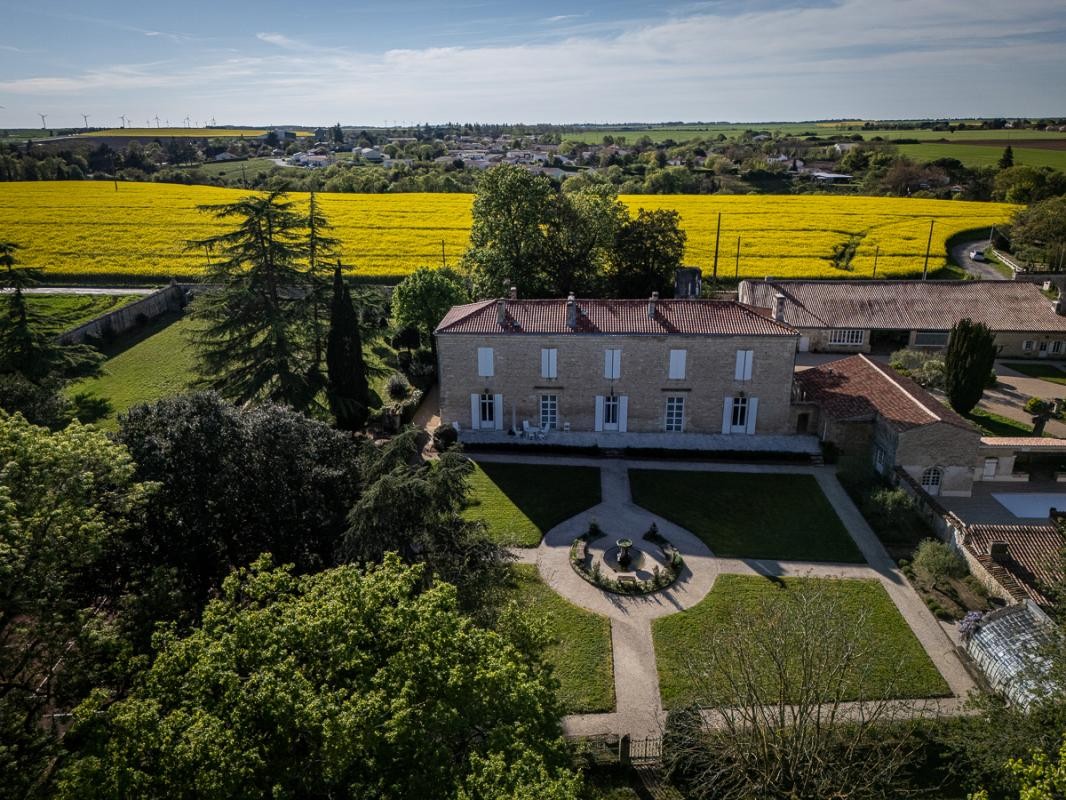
[69,318,196,428]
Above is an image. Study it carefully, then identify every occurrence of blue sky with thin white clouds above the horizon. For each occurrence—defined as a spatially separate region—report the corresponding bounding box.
[0,0,1066,127]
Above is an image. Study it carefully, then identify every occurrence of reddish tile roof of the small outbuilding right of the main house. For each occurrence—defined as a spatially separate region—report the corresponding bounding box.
[795,355,978,434]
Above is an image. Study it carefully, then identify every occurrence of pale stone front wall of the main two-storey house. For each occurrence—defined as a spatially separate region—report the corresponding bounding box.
[437,334,796,434]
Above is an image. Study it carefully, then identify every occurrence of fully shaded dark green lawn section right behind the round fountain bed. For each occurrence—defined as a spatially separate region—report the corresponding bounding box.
[629,469,863,563]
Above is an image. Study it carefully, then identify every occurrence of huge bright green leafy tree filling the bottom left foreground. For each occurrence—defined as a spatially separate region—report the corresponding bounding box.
[59,556,580,800]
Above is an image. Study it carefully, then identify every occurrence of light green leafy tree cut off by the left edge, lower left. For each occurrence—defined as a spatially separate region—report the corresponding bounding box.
[0,412,151,798]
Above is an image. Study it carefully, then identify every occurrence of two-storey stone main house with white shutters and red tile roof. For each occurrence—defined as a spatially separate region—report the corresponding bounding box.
[434,292,808,449]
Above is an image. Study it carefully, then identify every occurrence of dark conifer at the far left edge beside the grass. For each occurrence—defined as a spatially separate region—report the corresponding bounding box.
[0,242,102,428]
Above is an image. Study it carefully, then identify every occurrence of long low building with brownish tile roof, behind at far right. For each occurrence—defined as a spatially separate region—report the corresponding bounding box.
[739,277,1066,358]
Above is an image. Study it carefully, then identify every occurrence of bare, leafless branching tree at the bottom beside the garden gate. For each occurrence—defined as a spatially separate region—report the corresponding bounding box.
[663,580,936,800]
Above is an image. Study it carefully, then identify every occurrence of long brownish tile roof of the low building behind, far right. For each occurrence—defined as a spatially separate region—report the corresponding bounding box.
[740,279,1066,334]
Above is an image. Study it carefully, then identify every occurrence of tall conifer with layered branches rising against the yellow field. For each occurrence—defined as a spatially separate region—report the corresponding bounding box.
[190,191,323,410]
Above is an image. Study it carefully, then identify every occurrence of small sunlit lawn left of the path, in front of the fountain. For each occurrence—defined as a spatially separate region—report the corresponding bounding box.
[510,564,614,714]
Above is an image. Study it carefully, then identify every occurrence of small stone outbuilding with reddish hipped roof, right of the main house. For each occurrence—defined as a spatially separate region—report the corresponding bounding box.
[793,355,981,497]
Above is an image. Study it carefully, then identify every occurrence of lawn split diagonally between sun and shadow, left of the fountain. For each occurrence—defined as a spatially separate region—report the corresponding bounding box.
[466,461,600,547]
